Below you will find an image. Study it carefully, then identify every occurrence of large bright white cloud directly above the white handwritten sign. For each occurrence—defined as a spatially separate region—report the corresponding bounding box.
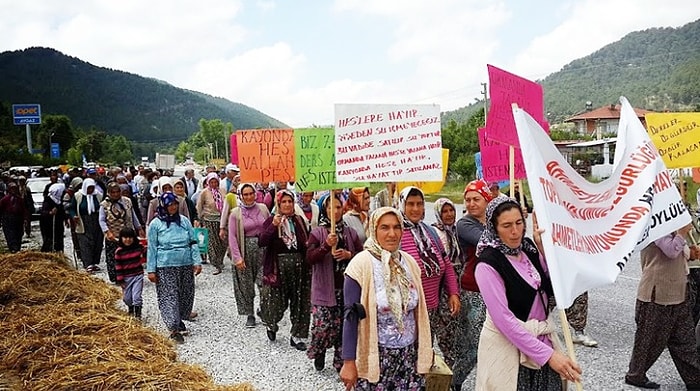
[328,0,510,110]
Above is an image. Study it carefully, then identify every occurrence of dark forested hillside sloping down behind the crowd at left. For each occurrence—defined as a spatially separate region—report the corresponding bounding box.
[0,48,285,143]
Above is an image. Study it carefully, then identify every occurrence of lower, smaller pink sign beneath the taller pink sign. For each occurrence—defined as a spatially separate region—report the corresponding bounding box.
[477,128,527,182]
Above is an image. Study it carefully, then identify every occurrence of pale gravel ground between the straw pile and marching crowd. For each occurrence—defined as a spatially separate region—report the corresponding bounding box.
[74,243,345,391]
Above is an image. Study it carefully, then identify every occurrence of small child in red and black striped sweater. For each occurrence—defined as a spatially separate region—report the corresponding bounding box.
[114,228,146,319]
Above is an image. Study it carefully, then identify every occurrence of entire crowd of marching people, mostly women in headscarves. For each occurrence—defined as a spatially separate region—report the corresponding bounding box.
[0,164,700,390]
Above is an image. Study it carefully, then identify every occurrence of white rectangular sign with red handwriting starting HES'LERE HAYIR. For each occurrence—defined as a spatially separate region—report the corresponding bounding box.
[335,104,442,182]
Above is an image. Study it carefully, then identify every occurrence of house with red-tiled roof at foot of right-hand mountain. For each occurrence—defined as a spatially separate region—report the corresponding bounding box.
[564,102,651,140]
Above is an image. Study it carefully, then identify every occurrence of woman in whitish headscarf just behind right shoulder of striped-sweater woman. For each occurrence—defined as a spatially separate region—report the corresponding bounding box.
[432,198,468,368]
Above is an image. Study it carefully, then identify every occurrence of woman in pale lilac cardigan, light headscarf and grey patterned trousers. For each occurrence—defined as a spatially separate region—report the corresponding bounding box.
[228,183,270,328]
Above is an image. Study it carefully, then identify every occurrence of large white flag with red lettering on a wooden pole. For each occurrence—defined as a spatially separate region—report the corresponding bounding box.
[513,97,691,308]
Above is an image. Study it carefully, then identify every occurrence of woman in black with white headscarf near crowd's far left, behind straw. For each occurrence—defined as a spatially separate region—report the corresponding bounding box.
[39,182,66,252]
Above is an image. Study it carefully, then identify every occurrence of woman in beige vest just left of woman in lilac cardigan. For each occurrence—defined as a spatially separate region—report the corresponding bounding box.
[197,172,227,275]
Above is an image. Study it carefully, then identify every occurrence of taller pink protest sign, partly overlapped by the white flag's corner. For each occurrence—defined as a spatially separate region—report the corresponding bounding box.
[486,65,549,147]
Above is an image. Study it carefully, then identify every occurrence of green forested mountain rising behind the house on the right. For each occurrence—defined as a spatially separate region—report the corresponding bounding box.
[443,20,700,123]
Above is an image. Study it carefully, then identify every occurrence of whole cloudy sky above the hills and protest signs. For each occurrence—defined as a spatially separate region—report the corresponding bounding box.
[0,0,700,127]
